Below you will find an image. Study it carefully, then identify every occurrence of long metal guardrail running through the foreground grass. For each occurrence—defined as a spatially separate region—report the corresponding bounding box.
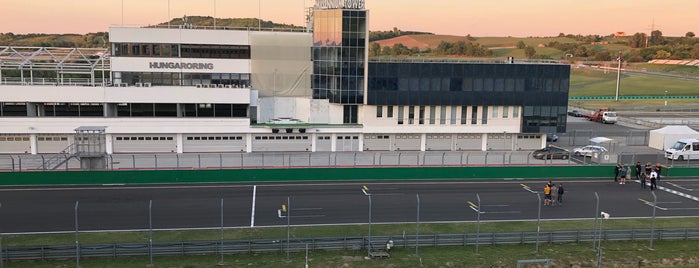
[2,228,699,261]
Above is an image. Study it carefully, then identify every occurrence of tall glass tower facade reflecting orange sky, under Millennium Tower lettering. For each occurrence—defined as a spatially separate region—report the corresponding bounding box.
[312,9,368,104]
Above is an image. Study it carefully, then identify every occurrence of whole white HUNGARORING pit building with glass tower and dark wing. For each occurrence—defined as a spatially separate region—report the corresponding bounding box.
[0,1,570,157]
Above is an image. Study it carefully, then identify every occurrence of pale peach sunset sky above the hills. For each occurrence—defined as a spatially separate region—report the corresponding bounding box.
[0,0,699,37]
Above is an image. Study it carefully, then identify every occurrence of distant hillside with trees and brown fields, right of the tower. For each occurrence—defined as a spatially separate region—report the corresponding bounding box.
[369,34,699,62]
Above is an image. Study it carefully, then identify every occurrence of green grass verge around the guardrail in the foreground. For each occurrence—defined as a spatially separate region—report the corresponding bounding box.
[3,218,699,268]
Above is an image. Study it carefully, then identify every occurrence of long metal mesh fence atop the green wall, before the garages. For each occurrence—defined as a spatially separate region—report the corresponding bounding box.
[0,151,699,172]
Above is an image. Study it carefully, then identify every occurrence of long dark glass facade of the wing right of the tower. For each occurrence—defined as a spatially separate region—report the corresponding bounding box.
[367,62,570,133]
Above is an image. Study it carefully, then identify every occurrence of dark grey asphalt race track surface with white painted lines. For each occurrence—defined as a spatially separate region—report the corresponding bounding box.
[0,178,699,234]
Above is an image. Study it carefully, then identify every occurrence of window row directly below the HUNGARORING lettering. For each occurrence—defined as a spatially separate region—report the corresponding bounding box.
[121,72,250,88]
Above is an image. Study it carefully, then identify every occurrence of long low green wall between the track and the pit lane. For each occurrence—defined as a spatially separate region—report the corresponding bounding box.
[0,166,699,186]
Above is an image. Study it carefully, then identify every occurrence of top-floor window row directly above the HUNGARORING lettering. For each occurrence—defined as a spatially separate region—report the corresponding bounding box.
[112,43,250,59]
